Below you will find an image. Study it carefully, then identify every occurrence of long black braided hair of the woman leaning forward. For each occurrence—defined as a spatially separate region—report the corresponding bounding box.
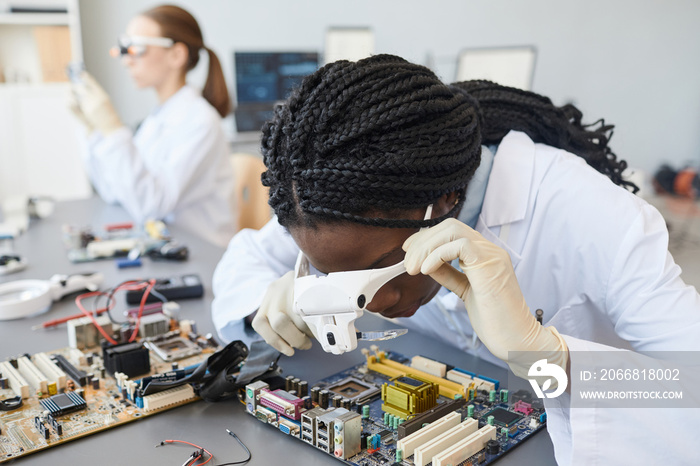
[262,55,636,228]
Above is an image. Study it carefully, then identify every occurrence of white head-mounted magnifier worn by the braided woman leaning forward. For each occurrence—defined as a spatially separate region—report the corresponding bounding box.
[293,205,433,354]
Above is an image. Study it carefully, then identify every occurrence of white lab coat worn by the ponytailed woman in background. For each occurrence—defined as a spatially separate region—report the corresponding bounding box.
[84,86,235,246]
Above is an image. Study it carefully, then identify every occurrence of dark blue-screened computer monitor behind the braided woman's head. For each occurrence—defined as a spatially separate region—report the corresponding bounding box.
[233,52,318,133]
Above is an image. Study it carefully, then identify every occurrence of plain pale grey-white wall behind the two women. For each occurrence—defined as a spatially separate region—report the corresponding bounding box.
[80,0,700,172]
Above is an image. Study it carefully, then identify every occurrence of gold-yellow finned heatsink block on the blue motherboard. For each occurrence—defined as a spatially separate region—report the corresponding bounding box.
[382,376,439,419]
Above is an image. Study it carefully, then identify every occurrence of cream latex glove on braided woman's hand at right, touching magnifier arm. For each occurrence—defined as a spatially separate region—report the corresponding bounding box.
[403,218,569,378]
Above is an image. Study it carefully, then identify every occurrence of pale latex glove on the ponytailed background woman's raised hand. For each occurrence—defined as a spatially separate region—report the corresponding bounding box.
[71,71,124,136]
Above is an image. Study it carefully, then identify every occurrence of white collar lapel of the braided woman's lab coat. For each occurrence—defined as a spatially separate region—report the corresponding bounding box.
[481,131,535,228]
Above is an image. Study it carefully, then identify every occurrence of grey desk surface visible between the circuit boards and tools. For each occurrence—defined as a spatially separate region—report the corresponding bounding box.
[0,199,556,466]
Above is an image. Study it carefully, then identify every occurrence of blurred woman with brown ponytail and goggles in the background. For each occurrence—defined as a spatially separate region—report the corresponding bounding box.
[71,5,235,246]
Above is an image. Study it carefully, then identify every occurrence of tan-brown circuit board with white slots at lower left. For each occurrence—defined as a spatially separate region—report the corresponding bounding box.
[0,315,218,463]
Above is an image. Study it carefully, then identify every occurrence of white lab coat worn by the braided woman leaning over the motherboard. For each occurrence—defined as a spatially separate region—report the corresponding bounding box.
[212,131,700,465]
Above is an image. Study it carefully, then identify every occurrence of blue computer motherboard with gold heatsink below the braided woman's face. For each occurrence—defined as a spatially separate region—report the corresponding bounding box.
[240,347,547,466]
